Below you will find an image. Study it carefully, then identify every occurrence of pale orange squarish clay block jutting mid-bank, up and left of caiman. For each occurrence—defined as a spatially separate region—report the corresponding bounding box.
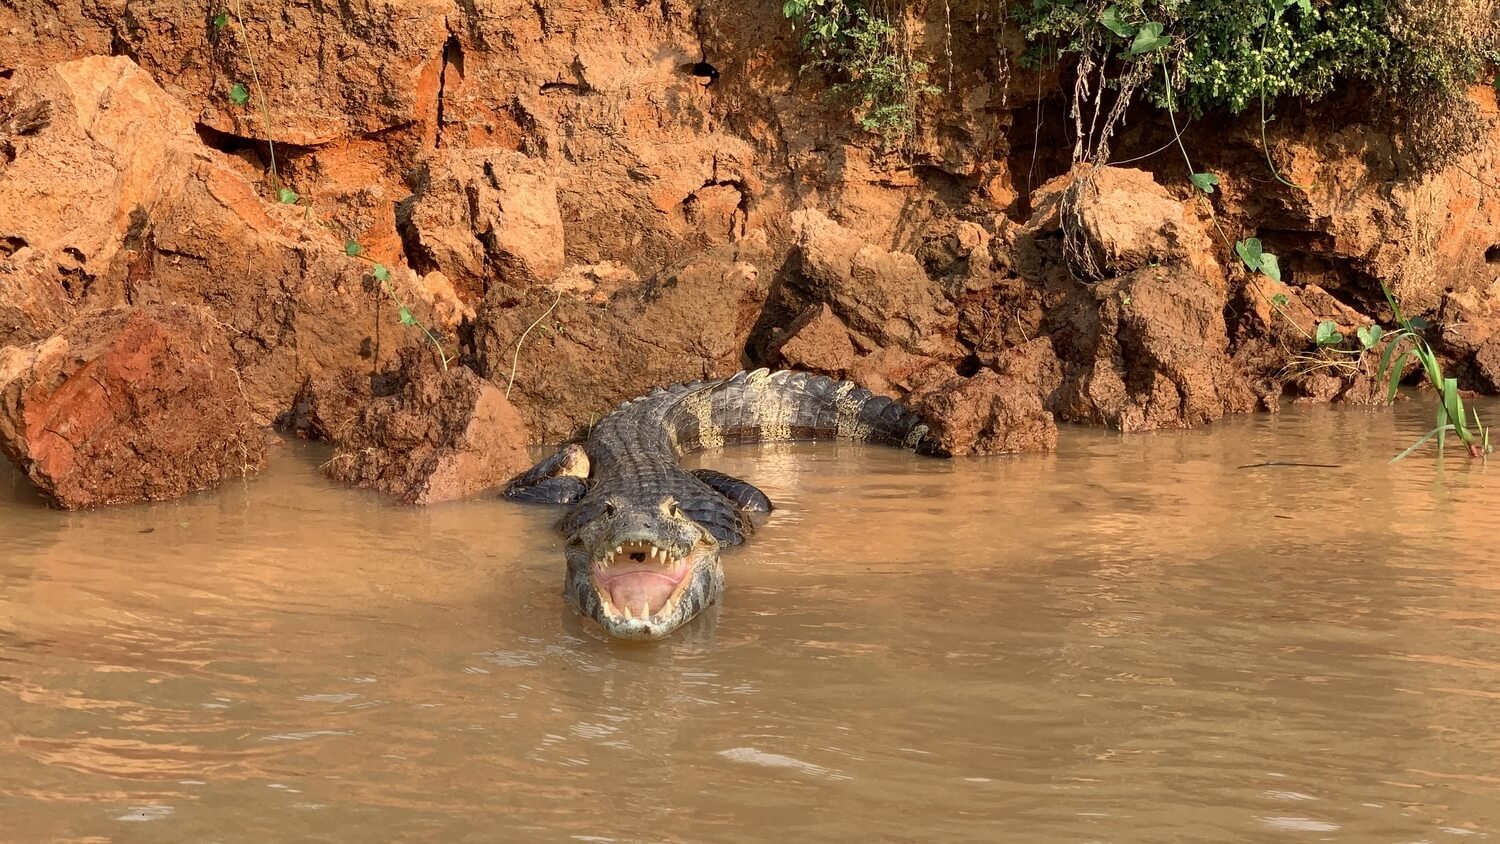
[399,148,564,294]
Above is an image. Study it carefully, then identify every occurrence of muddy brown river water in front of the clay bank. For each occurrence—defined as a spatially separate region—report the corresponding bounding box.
[0,402,1500,843]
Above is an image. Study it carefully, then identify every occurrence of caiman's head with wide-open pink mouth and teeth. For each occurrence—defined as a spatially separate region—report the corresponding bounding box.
[564,496,725,639]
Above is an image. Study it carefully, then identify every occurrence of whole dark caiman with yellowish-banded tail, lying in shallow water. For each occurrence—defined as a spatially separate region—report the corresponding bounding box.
[504,369,942,639]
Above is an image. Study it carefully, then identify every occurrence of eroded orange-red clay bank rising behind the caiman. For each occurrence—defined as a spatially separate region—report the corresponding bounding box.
[0,0,1500,509]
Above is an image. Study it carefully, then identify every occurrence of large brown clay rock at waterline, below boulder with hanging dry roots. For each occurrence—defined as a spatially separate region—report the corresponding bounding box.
[1052,265,1256,430]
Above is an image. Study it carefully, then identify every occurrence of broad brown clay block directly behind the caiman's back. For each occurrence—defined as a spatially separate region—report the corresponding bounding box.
[474,247,770,442]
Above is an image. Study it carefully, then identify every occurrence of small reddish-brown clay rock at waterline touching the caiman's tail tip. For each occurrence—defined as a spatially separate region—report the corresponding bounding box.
[908,370,1058,456]
